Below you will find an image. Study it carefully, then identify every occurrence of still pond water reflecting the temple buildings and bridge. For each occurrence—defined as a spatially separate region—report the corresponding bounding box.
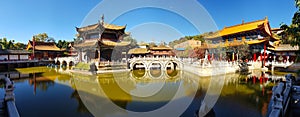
[2,67,290,117]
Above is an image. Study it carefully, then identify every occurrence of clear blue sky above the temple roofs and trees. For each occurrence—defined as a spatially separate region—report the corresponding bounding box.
[0,0,296,43]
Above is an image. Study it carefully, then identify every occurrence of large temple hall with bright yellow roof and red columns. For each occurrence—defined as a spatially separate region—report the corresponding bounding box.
[205,17,280,61]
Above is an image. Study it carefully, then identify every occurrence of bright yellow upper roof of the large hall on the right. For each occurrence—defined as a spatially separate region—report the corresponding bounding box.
[207,18,271,38]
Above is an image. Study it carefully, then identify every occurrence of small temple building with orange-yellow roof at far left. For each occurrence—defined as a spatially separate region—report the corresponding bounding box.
[26,40,63,60]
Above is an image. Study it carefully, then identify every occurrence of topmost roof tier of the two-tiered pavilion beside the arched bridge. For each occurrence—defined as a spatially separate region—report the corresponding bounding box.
[76,23,126,32]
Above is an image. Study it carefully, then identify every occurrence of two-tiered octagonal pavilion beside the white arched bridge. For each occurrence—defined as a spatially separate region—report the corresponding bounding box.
[74,16,130,62]
